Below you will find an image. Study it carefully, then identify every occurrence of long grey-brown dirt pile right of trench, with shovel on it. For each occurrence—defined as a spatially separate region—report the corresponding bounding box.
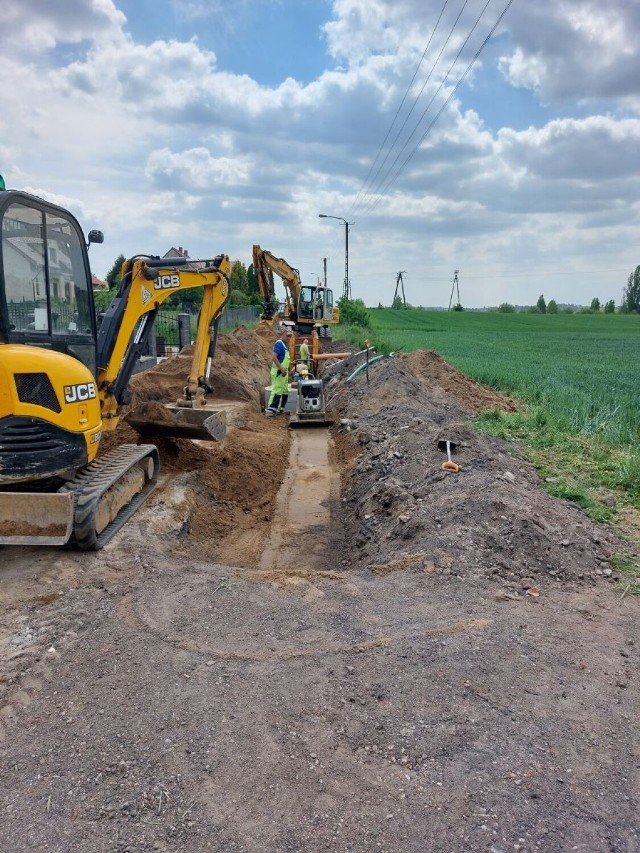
[325,351,620,595]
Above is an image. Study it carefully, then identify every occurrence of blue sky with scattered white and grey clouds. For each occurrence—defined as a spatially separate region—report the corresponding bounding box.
[0,0,640,308]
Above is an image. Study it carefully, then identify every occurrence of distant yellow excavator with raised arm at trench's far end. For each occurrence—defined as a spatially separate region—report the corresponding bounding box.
[253,246,340,338]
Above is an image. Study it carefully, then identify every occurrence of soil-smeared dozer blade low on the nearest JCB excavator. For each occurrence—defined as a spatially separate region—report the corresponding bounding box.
[0,492,73,545]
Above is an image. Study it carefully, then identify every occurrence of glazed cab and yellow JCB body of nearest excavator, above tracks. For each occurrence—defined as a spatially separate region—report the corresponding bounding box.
[0,190,102,483]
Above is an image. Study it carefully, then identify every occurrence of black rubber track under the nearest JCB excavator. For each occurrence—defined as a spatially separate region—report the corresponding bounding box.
[58,444,160,551]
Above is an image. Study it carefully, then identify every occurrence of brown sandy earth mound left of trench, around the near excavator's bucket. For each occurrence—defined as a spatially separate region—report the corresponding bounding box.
[101,327,289,566]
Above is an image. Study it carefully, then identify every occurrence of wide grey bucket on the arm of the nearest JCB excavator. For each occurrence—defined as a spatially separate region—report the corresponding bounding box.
[125,403,227,441]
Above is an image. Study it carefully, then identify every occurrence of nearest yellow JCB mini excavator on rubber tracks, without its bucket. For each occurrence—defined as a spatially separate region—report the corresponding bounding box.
[0,189,230,550]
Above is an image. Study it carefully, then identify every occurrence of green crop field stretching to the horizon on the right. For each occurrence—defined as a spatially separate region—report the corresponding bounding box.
[369,309,640,448]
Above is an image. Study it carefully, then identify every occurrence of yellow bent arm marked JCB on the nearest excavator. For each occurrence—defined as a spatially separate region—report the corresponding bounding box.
[97,255,231,431]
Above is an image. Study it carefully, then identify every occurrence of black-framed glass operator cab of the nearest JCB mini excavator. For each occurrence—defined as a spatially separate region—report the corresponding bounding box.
[0,190,102,373]
